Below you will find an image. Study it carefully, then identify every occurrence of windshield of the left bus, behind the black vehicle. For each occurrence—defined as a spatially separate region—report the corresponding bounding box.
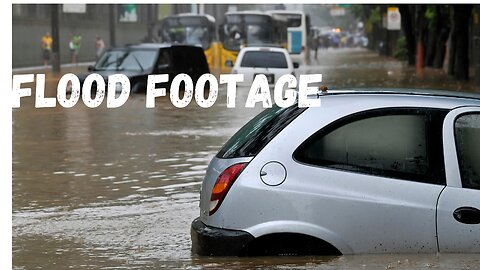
[159,17,213,50]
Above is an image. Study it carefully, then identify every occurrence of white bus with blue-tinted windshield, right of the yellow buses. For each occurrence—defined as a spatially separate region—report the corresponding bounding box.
[268,10,310,64]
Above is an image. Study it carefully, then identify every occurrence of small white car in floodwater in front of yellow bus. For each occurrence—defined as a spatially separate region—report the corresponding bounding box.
[232,47,298,85]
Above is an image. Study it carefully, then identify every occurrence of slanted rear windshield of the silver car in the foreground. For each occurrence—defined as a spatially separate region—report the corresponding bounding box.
[217,104,306,158]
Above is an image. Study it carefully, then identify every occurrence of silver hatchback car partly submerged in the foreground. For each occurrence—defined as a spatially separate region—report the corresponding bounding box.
[191,90,480,255]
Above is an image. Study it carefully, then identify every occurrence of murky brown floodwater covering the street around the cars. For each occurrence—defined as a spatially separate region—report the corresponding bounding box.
[13,49,480,269]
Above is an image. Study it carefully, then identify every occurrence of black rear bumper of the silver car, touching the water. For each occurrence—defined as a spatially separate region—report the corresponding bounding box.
[190,218,254,256]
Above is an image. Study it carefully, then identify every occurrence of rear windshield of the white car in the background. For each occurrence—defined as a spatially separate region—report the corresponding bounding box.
[240,51,288,68]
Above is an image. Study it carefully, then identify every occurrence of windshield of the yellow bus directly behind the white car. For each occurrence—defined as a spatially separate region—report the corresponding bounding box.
[222,14,273,51]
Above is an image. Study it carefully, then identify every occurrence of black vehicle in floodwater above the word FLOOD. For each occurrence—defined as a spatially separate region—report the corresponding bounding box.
[80,43,210,93]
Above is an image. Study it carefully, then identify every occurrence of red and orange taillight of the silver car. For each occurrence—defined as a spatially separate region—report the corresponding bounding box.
[209,163,247,216]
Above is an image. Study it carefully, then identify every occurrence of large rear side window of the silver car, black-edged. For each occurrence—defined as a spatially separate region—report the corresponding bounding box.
[294,108,445,185]
